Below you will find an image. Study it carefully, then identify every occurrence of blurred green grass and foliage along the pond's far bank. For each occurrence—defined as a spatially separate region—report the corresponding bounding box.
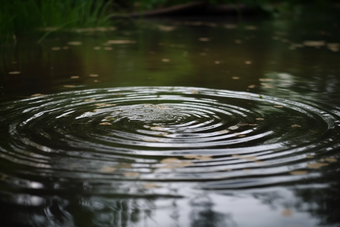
[0,0,336,39]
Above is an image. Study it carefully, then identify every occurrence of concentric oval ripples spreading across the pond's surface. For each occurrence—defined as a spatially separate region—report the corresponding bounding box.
[0,87,340,199]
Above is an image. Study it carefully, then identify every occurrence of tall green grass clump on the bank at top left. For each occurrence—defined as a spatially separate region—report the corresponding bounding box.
[0,0,114,40]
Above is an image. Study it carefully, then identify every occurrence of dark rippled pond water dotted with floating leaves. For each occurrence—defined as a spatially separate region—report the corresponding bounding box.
[0,13,340,227]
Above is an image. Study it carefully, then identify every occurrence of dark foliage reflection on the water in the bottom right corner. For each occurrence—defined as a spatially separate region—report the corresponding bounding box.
[253,156,340,226]
